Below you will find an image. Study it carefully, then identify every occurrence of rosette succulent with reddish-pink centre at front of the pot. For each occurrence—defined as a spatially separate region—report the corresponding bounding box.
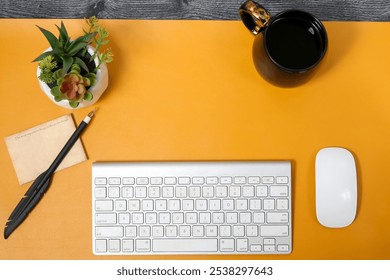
[51,64,96,108]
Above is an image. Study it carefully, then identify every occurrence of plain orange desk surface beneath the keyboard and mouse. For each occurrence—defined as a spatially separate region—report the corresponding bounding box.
[0,19,390,259]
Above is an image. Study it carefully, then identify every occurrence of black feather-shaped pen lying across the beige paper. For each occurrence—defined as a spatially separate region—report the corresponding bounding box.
[4,110,95,239]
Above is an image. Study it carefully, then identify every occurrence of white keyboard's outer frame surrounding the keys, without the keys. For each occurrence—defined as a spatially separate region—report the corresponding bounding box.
[92,161,292,255]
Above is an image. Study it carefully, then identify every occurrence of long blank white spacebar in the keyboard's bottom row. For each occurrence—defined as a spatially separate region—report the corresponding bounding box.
[152,238,218,253]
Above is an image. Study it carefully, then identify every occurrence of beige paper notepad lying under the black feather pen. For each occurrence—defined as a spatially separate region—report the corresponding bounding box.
[5,115,87,185]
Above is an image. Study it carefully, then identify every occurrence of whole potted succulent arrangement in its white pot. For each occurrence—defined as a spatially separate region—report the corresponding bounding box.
[34,17,113,109]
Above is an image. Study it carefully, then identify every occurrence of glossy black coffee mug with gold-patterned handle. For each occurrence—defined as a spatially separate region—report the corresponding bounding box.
[240,0,328,87]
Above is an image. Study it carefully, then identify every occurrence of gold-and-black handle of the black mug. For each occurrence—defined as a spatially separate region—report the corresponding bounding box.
[239,0,271,35]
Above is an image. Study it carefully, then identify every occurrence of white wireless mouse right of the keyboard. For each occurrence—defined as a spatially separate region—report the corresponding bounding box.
[315,147,357,228]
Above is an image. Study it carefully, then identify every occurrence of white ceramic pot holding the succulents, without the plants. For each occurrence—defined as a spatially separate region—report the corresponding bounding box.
[37,46,108,110]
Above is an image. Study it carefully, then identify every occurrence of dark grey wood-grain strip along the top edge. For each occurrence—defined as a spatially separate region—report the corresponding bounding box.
[0,0,390,21]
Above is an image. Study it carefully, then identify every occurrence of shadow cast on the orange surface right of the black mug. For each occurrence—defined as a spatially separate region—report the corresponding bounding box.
[316,22,357,76]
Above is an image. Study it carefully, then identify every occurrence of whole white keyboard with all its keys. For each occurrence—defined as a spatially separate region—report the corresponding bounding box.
[92,161,292,255]
